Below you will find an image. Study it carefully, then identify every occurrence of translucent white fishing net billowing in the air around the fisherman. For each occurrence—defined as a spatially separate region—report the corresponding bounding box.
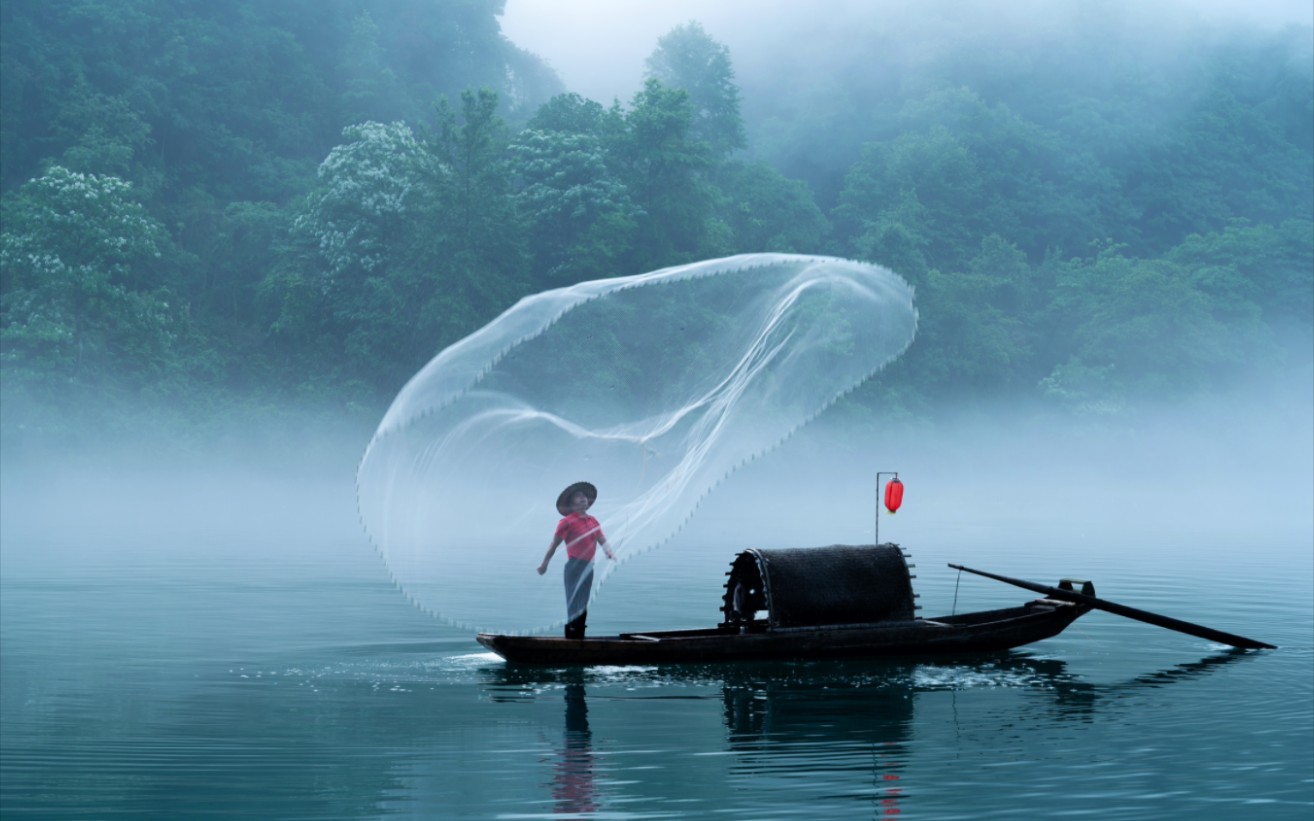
[357,254,917,633]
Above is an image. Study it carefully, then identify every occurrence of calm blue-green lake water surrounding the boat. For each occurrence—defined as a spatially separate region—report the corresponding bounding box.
[0,438,1314,820]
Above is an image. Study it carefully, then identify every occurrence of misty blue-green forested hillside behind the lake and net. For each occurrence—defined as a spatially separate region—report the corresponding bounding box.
[0,0,1314,447]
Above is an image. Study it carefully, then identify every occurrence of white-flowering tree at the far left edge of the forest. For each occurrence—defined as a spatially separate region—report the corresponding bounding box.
[0,166,188,393]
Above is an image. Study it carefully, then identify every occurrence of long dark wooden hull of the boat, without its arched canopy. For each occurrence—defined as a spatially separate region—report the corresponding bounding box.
[476,599,1091,666]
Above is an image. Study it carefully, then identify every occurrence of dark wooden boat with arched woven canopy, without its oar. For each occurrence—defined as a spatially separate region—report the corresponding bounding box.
[477,544,1095,666]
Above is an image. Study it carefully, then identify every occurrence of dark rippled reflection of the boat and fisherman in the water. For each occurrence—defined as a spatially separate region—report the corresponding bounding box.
[482,652,1252,817]
